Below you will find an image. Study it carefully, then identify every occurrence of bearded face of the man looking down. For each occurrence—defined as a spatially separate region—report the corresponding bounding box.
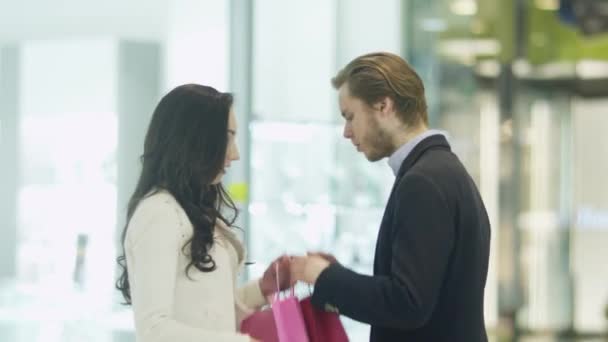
[338,83,393,162]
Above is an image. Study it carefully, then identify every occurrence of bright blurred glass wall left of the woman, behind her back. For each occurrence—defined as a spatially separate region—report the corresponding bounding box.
[0,0,224,342]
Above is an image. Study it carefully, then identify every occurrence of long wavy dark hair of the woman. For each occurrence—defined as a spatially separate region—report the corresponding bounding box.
[116,84,238,304]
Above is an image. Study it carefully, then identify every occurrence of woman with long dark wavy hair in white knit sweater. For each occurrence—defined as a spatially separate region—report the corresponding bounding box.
[117,84,289,342]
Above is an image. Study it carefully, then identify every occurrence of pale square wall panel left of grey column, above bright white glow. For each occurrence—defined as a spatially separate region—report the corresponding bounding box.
[19,39,117,116]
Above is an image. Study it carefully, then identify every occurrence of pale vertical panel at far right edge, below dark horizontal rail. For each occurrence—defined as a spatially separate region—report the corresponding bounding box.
[570,97,608,331]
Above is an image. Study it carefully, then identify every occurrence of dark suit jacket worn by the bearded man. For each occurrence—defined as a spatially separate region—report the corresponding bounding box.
[312,135,490,342]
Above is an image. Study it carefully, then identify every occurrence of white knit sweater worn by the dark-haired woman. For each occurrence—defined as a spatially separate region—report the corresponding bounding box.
[125,191,266,342]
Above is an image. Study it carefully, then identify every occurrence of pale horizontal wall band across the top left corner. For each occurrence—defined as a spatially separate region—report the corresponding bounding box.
[0,0,168,42]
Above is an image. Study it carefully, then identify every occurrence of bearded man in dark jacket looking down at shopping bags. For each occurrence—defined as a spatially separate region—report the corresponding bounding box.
[291,53,490,342]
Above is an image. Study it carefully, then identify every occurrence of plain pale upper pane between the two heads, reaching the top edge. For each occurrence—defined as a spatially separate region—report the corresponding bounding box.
[252,0,336,121]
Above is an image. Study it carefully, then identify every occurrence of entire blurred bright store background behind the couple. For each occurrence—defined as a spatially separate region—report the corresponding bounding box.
[0,0,608,342]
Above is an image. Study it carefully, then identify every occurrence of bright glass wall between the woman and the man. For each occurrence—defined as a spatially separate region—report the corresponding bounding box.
[248,0,401,341]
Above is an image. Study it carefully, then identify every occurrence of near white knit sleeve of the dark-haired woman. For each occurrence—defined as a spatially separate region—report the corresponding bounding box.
[125,196,250,342]
